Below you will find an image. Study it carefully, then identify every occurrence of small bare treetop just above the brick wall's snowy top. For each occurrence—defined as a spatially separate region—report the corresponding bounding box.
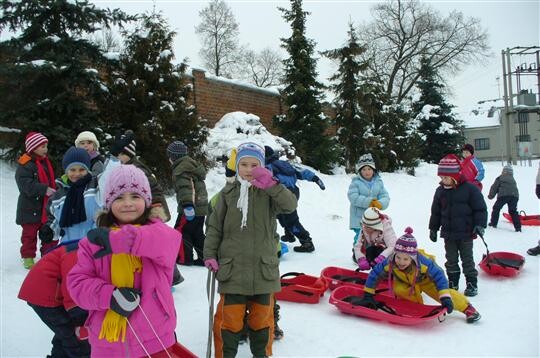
[238,47,283,87]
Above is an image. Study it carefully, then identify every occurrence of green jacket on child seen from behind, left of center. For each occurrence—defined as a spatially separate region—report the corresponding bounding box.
[172,156,208,216]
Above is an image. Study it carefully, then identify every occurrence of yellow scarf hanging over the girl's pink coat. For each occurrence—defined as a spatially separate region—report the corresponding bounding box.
[99,227,142,342]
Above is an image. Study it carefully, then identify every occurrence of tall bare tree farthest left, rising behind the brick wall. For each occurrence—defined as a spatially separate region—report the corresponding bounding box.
[195,0,239,77]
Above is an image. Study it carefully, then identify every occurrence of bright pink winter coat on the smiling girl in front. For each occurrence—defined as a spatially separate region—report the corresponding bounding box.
[68,220,181,357]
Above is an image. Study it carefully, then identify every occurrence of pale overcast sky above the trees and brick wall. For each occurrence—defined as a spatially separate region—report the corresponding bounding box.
[86,0,540,111]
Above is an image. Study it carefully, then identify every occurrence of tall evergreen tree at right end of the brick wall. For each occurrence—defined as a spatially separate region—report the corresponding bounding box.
[274,0,337,172]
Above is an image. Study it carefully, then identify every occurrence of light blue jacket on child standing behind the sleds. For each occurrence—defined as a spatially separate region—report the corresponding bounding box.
[347,174,390,229]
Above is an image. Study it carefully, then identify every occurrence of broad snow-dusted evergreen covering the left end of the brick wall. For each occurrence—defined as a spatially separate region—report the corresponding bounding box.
[103,12,208,183]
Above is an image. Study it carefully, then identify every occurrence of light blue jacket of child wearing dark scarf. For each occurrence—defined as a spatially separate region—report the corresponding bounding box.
[47,178,100,242]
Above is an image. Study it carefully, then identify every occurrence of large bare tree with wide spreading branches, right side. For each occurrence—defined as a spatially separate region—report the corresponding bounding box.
[359,0,489,103]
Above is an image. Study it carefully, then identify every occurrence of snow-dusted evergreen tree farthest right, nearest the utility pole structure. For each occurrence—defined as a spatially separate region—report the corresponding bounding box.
[413,58,464,163]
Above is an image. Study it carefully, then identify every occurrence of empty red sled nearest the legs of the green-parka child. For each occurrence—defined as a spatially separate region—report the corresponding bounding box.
[276,272,328,303]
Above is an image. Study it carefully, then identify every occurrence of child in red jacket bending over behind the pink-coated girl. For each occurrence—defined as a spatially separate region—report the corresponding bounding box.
[18,240,90,357]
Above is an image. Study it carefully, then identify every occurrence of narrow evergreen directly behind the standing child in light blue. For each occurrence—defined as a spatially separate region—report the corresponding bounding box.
[323,23,369,173]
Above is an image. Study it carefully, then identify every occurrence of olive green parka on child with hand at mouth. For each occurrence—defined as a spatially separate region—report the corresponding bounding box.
[203,181,297,296]
